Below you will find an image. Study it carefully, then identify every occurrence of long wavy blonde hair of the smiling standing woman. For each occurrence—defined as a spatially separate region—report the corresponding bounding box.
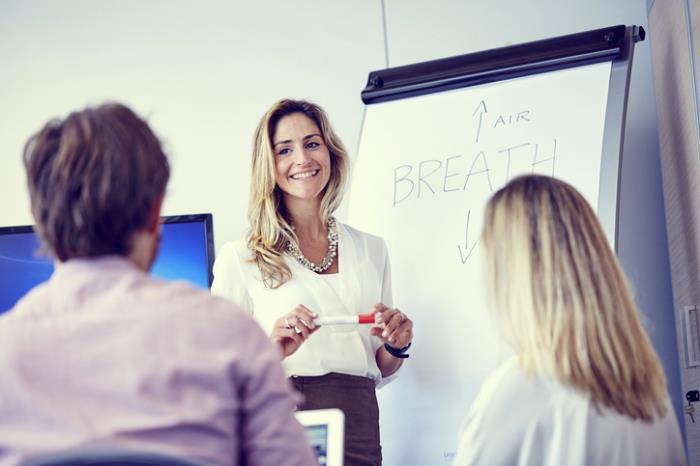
[246,99,348,289]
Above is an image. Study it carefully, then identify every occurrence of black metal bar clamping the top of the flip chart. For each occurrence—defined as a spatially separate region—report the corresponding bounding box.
[362,25,645,104]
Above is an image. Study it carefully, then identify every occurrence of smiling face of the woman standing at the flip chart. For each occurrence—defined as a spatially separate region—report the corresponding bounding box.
[272,113,331,206]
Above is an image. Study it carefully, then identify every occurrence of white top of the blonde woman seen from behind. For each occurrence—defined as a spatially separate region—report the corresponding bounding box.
[453,359,686,466]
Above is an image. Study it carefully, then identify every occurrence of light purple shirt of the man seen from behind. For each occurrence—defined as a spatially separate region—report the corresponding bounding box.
[0,257,316,466]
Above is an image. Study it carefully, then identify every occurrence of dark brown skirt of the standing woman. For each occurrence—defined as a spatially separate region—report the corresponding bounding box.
[290,372,382,466]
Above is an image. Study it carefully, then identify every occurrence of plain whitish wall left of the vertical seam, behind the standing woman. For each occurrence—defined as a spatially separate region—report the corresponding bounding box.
[0,0,384,249]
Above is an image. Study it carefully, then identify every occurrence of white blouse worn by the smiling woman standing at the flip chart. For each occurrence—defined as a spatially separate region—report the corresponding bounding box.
[211,222,396,384]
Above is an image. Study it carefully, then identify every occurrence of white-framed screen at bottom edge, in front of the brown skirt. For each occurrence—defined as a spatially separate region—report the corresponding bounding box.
[294,409,345,466]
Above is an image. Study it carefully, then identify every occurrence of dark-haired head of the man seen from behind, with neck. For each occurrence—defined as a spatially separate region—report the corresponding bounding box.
[24,103,170,268]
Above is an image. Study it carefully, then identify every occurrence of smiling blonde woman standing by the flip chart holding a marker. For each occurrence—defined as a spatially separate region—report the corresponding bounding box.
[212,100,413,466]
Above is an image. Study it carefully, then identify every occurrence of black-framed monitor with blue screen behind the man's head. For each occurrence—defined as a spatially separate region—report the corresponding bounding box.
[0,214,214,314]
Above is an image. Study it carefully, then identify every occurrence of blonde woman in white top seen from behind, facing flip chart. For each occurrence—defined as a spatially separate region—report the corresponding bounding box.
[454,176,685,466]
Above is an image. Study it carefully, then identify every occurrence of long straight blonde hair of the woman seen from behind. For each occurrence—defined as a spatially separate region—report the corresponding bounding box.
[482,175,667,422]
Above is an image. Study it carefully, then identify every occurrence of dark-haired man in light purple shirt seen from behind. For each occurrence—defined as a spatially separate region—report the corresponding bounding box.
[0,104,316,466]
